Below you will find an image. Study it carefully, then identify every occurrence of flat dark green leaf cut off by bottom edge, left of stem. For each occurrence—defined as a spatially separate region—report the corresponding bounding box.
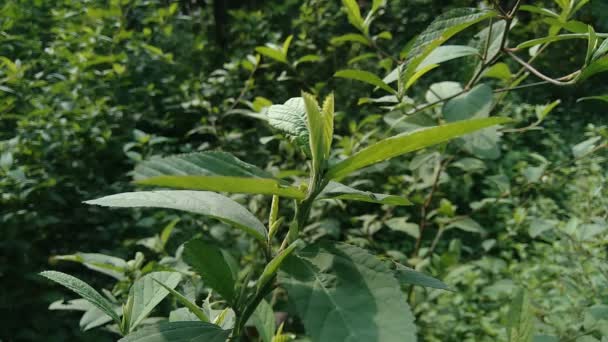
[118,322,230,342]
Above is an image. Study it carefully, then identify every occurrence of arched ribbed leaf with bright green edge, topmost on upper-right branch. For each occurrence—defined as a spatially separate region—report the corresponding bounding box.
[400,8,497,92]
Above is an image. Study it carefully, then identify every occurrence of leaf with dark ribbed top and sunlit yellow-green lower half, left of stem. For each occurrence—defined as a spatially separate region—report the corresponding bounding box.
[134,153,304,199]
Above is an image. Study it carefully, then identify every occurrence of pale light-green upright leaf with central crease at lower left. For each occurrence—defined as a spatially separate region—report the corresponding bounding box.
[128,272,182,332]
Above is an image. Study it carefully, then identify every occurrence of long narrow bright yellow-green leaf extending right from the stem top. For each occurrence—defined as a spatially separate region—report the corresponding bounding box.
[327,117,511,179]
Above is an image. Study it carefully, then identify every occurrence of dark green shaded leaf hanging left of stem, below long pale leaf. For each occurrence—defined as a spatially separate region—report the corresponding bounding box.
[184,239,237,303]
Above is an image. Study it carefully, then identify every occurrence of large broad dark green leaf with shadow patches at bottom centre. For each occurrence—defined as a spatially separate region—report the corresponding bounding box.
[280,244,416,342]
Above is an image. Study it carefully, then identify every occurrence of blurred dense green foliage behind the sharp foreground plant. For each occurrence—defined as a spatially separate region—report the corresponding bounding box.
[0,0,608,341]
